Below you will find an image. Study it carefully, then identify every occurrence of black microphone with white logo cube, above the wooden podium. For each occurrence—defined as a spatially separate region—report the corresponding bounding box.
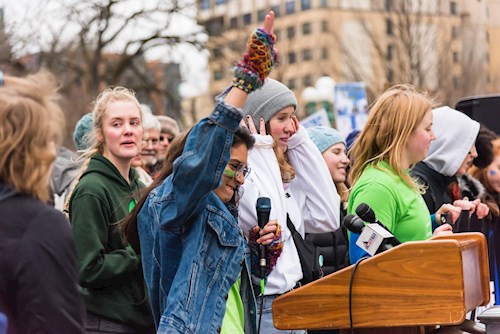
[342,214,394,256]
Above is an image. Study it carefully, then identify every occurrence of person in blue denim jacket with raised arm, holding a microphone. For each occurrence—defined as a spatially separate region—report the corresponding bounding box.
[121,12,276,333]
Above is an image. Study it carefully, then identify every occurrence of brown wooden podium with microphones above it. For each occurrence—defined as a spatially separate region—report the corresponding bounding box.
[273,233,490,333]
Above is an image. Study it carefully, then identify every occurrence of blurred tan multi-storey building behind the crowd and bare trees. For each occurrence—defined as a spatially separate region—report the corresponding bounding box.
[198,0,500,116]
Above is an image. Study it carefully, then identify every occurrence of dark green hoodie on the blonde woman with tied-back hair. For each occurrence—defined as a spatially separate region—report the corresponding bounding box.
[69,155,154,328]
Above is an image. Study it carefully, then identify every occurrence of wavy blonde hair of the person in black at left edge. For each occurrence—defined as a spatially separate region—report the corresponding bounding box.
[0,71,65,202]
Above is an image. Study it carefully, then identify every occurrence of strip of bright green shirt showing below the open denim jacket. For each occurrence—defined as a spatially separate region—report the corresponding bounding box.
[221,276,245,334]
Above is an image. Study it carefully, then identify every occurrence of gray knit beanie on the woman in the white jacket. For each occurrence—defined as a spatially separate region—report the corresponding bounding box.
[243,78,298,130]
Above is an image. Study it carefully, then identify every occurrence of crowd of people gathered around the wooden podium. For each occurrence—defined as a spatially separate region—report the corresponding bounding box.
[0,12,500,334]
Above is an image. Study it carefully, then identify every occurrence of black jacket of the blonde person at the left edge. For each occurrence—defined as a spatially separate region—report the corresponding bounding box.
[0,184,85,334]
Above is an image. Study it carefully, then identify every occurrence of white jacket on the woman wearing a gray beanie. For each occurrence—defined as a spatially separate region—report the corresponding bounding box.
[239,127,340,295]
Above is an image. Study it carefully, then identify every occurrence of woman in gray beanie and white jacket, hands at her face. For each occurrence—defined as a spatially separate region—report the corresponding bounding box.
[239,79,340,333]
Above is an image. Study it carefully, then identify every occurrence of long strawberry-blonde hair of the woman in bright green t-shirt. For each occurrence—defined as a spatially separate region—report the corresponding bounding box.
[349,85,434,192]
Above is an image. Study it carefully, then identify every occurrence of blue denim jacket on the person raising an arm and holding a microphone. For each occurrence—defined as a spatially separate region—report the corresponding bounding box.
[138,102,255,333]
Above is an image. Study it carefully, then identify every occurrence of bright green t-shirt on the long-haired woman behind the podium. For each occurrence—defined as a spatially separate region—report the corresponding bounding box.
[348,162,432,242]
